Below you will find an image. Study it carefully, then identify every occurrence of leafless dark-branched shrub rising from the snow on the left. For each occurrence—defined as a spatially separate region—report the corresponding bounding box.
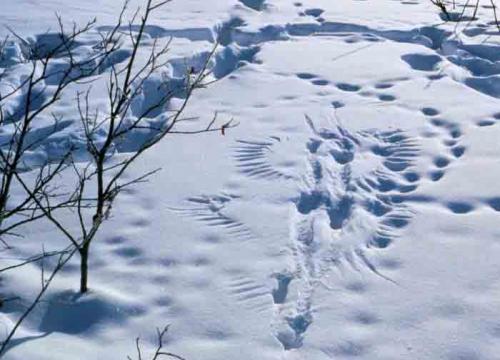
[0,0,234,359]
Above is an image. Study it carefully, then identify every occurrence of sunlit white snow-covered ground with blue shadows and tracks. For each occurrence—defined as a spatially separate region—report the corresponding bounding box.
[0,0,500,360]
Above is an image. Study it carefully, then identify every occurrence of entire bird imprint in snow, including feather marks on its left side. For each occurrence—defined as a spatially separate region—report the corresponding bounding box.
[171,111,465,350]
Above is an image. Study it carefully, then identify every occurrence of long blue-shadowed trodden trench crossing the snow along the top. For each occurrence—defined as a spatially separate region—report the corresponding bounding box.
[93,16,500,97]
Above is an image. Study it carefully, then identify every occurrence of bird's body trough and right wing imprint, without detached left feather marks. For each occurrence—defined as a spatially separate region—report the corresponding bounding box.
[273,118,420,350]
